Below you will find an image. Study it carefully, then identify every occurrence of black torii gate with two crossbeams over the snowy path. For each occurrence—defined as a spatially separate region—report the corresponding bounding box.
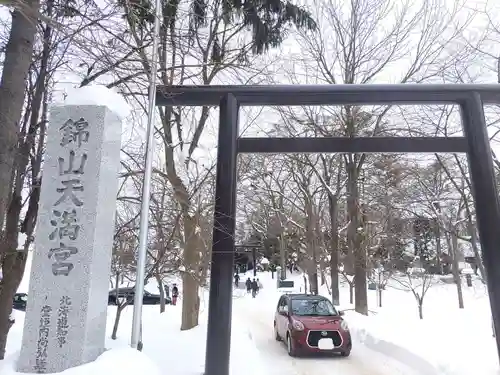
[156,84,500,375]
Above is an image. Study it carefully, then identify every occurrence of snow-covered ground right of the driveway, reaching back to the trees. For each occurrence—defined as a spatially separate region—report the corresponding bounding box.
[332,281,500,375]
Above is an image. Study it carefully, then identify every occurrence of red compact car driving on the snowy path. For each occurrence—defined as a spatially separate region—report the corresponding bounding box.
[274,294,352,357]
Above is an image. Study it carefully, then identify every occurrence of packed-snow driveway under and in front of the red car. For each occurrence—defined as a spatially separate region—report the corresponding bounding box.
[233,296,421,375]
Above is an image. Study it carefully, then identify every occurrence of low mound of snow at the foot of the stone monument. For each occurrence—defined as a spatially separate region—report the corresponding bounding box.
[0,348,160,375]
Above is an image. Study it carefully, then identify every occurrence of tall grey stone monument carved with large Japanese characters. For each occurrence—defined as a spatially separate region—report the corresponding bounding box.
[17,105,122,373]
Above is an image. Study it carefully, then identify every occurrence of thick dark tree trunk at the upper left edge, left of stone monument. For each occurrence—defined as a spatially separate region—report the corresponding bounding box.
[0,0,40,235]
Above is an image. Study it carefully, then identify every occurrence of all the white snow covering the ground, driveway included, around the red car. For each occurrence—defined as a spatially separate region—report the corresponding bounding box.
[0,262,500,375]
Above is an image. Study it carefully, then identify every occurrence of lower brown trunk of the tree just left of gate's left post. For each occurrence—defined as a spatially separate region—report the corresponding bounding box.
[181,214,199,331]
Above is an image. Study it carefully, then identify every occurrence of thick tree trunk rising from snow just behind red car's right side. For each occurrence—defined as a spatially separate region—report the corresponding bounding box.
[347,160,368,315]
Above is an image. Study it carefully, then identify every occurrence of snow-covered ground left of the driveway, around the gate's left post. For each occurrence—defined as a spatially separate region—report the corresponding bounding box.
[4,306,267,375]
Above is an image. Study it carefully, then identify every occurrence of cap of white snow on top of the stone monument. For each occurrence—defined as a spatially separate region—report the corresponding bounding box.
[56,85,131,120]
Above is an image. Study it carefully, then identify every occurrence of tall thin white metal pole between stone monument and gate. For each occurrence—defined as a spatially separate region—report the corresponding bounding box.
[130,0,161,349]
